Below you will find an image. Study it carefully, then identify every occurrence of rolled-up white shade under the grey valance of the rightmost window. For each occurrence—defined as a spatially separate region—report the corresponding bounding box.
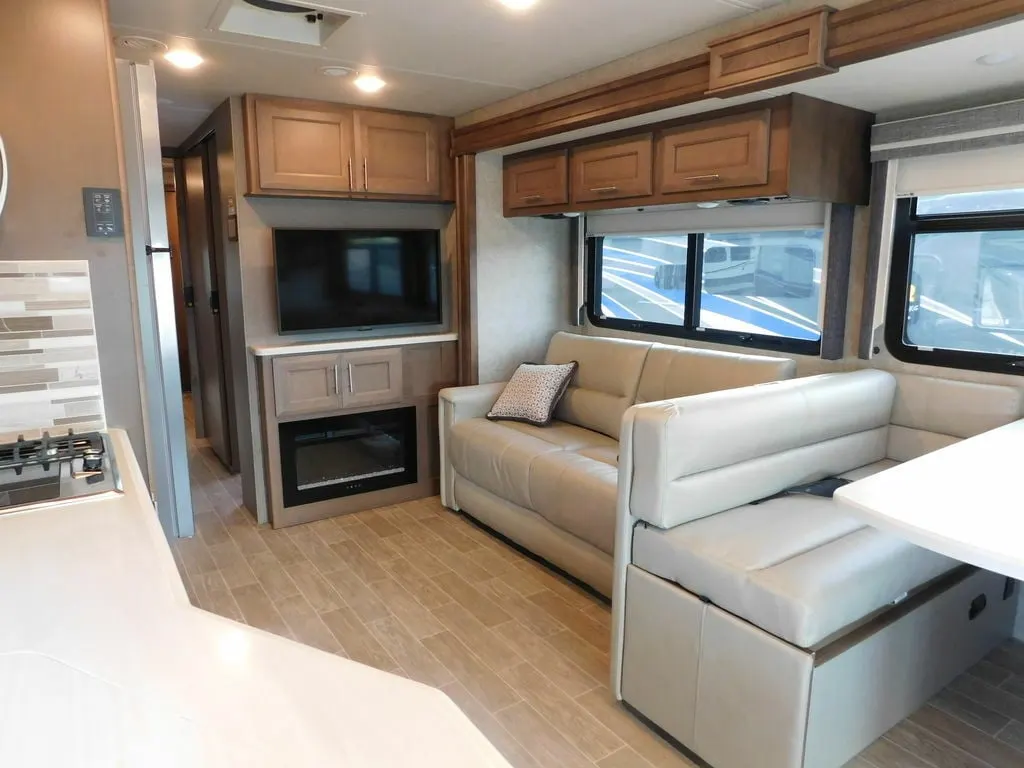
[894,144,1024,198]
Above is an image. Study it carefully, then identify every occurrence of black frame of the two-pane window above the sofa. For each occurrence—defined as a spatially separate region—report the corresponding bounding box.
[586,233,827,357]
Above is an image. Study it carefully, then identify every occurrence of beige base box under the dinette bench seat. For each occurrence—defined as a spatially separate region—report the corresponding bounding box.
[622,565,1017,768]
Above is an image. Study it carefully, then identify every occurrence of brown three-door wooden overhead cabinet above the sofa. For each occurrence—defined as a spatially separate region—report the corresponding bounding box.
[505,93,874,216]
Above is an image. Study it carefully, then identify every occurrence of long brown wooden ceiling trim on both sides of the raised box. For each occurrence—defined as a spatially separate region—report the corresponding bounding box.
[454,0,1024,155]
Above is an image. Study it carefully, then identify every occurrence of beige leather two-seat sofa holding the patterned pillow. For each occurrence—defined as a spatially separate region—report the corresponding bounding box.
[439,333,796,595]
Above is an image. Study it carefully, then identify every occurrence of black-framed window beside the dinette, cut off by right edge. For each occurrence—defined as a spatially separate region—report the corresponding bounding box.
[886,189,1024,373]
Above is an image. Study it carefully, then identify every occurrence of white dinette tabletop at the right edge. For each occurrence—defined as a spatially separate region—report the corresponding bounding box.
[835,420,1024,580]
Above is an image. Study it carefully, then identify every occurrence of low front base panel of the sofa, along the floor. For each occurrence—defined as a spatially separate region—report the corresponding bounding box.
[447,470,613,596]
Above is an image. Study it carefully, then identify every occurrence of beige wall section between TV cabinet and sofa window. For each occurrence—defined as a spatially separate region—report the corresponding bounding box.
[475,153,571,383]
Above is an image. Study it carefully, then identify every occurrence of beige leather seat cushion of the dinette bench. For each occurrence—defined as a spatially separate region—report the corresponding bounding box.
[633,463,958,648]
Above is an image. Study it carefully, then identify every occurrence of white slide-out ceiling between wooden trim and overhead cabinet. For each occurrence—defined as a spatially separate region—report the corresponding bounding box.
[501,22,1024,155]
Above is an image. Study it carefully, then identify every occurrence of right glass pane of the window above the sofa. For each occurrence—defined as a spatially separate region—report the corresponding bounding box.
[699,229,824,341]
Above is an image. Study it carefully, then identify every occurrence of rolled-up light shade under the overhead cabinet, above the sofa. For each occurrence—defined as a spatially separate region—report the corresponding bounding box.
[587,203,828,237]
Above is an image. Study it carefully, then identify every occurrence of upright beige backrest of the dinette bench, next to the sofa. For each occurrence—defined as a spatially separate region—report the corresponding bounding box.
[620,371,896,528]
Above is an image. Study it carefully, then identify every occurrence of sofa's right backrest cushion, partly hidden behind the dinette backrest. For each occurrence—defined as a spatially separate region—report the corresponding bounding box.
[637,344,797,402]
